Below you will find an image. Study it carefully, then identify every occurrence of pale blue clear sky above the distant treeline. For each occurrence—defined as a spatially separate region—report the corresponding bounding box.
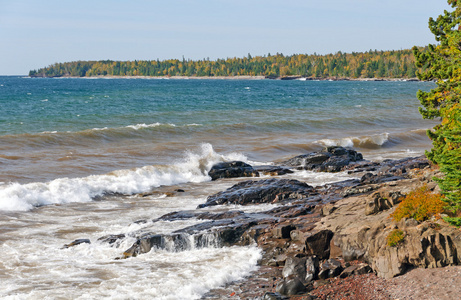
[0,0,450,75]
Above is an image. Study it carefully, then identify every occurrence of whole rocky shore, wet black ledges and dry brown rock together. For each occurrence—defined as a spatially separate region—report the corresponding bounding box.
[66,147,461,299]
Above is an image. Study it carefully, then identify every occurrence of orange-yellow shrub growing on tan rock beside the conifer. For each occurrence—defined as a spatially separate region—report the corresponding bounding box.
[391,185,446,222]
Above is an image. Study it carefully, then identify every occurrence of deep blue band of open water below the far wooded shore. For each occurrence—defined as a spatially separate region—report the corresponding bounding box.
[0,77,432,135]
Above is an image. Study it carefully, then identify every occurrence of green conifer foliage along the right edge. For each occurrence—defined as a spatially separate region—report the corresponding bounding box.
[413,0,461,212]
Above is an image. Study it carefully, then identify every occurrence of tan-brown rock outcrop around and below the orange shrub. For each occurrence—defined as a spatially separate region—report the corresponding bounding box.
[317,169,461,278]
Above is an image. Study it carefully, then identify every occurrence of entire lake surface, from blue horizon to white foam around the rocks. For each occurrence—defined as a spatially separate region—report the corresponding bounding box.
[0,77,435,299]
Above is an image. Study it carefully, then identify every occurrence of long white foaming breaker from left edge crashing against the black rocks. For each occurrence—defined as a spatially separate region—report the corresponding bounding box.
[0,144,247,211]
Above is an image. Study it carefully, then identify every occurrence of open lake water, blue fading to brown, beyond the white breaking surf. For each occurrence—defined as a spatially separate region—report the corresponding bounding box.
[0,77,434,182]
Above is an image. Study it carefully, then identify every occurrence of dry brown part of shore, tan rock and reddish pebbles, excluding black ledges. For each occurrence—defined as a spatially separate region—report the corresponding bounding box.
[196,157,461,300]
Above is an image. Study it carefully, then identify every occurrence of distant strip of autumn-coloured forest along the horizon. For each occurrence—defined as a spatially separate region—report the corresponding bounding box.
[29,50,424,79]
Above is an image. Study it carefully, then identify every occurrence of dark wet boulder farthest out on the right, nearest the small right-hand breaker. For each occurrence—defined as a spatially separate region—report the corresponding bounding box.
[282,146,363,172]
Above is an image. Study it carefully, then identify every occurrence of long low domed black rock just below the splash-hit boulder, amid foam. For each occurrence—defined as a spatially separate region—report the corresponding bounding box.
[198,178,316,208]
